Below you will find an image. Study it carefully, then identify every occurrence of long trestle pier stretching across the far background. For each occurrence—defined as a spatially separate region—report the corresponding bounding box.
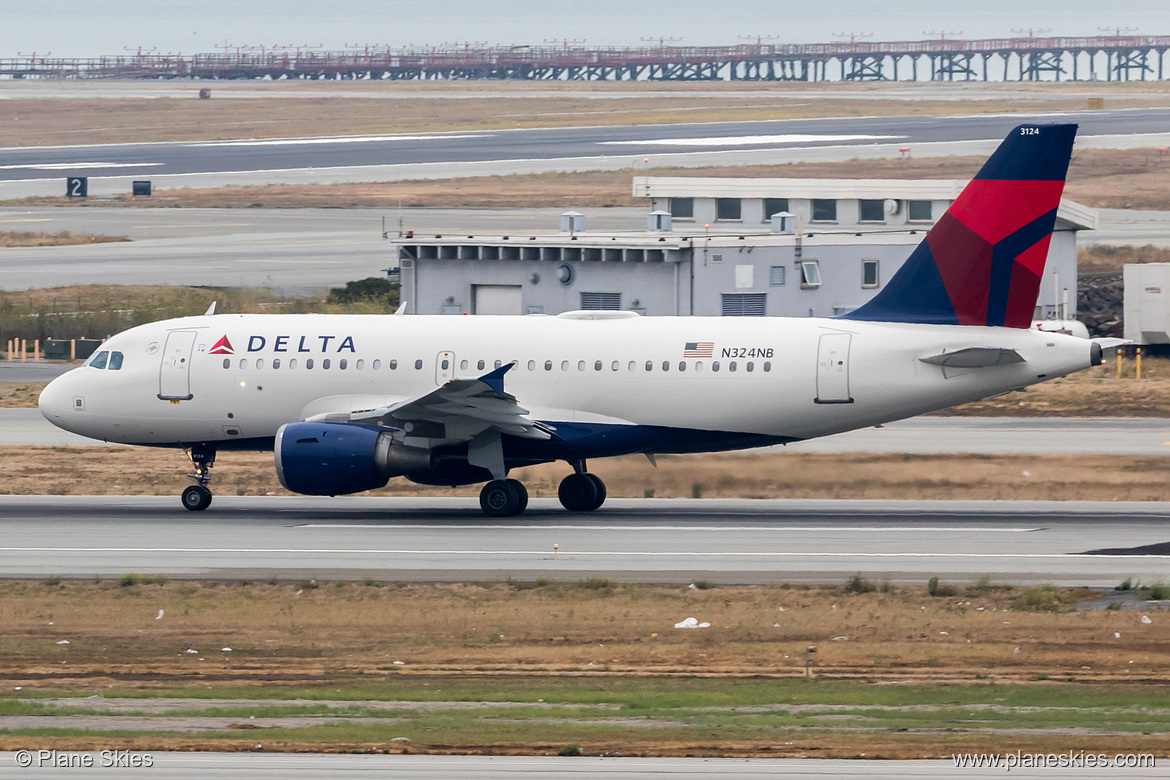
[0,35,1170,82]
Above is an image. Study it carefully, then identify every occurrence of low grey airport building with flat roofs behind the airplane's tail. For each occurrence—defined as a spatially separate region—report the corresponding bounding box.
[393,177,1096,318]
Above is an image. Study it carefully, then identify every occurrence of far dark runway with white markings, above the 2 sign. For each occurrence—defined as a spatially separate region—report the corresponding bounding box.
[0,109,1170,198]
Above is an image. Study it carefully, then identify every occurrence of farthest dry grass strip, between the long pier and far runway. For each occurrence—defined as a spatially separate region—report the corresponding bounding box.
[0,82,1166,146]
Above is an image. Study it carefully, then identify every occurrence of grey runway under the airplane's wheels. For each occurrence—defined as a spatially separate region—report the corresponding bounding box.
[0,496,1170,587]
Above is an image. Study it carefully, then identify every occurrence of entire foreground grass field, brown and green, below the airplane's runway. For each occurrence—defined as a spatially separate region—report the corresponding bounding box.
[0,575,1170,758]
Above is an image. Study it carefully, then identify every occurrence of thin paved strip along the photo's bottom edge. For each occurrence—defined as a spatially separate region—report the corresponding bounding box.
[0,753,1170,780]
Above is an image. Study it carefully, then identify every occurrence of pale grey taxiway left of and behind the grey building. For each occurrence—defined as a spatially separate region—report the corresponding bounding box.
[0,204,1170,295]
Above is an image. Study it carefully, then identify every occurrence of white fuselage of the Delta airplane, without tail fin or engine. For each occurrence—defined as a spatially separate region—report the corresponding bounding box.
[40,315,1090,446]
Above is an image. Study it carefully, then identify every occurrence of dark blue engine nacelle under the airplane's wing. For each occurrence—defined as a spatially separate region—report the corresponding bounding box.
[273,422,432,496]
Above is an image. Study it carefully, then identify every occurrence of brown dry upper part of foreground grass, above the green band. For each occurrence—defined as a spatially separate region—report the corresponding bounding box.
[0,581,1170,690]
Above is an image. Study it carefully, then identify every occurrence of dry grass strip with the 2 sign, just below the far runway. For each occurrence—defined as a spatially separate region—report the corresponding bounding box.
[13,149,1170,211]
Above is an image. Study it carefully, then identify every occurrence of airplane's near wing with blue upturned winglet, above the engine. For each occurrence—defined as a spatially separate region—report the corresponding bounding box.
[309,364,552,447]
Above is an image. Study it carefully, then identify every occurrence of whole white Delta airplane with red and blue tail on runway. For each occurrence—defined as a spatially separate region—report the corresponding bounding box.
[40,124,1102,517]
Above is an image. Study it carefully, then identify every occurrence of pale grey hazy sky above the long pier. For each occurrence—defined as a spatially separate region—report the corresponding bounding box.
[0,0,1170,56]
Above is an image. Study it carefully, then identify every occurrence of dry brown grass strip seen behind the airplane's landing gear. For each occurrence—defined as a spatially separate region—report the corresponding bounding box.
[0,447,1170,501]
